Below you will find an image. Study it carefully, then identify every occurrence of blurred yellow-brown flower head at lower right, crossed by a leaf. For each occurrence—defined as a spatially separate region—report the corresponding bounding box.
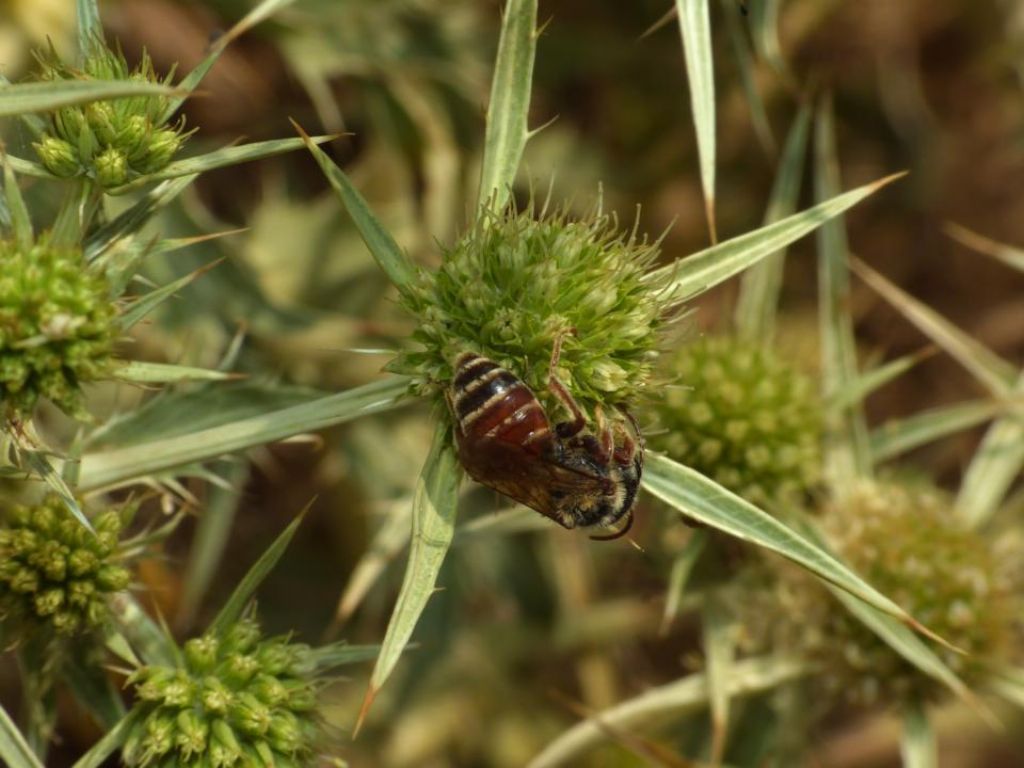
[760,483,1024,707]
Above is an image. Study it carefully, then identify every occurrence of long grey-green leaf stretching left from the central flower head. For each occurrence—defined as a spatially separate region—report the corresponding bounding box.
[79,377,409,490]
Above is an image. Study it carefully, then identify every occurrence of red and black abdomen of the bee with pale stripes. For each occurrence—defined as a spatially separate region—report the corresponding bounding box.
[450,352,551,447]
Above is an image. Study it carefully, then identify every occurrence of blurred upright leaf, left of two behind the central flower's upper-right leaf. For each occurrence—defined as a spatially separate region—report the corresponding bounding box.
[735,106,811,343]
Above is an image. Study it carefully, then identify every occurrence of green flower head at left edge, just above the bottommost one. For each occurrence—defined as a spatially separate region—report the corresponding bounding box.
[0,496,130,642]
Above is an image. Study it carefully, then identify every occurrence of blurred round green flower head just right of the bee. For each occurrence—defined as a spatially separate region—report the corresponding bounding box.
[649,337,822,509]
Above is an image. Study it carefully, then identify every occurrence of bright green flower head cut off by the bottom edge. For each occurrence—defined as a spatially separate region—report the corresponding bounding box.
[123,618,323,768]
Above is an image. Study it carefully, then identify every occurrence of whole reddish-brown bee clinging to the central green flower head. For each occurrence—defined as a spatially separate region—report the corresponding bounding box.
[446,340,643,540]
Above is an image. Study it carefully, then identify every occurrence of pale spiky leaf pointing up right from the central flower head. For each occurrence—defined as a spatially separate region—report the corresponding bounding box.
[646,173,903,303]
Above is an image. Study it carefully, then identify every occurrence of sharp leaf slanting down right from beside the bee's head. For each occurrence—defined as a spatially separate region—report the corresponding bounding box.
[643,454,937,630]
